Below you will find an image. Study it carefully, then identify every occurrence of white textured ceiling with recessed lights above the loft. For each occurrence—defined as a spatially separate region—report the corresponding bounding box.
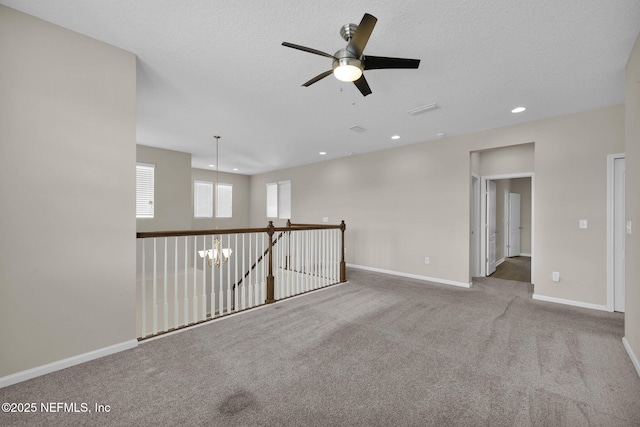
[0,0,640,175]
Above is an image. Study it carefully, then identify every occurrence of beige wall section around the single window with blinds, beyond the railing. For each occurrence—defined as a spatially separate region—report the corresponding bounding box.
[136,145,193,231]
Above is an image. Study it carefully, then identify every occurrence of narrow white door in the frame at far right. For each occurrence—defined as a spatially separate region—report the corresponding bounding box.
[613,158,625,312]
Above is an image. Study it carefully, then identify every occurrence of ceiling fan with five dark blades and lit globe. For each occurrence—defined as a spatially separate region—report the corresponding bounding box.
[282,13,420,96]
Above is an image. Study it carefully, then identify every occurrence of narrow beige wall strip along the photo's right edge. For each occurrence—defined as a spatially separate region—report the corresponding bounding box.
[624,36,640,374]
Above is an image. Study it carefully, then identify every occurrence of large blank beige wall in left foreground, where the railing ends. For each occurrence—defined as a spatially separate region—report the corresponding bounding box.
[0,6,136,378]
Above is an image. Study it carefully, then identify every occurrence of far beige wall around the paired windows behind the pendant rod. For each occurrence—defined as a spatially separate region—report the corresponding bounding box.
[190,169,250,230]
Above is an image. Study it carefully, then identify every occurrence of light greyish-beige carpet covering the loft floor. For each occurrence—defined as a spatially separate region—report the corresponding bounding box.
[0,270,640,427]
